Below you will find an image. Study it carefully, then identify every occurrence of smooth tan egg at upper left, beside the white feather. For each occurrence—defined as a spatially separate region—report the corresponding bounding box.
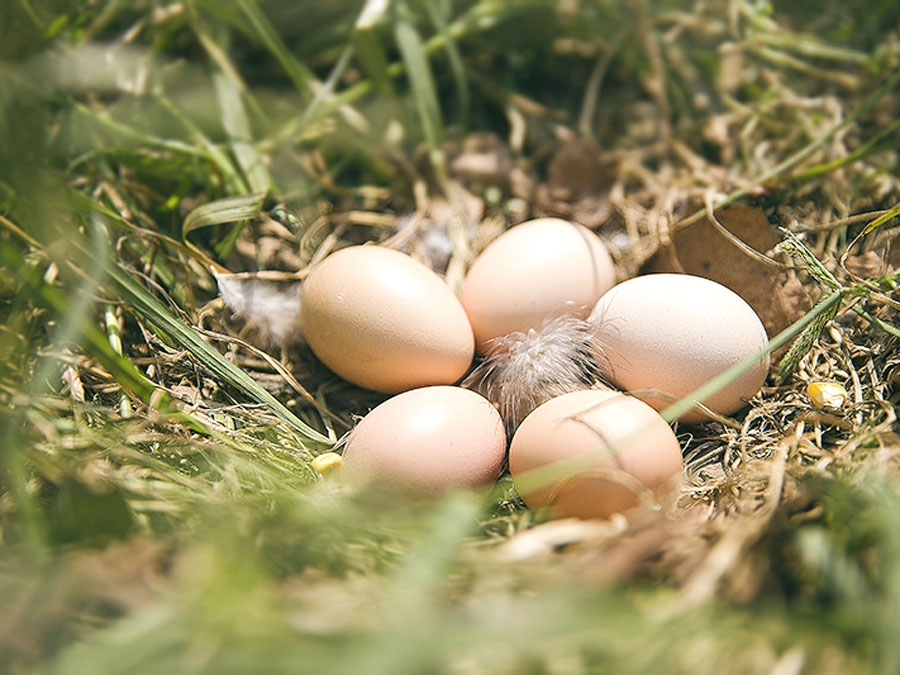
[300,246,475,394]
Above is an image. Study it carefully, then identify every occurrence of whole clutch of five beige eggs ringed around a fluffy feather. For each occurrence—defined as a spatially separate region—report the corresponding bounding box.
[290,218,768,518]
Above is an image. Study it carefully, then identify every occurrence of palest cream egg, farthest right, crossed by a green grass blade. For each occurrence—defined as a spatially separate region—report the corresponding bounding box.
[590,274,769,422]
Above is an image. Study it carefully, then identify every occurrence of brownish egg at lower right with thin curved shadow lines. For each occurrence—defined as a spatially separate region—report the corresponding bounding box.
[509,389,682,518]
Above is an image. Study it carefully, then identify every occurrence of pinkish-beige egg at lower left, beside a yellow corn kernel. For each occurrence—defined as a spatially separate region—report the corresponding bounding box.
[341,386,506,494]
